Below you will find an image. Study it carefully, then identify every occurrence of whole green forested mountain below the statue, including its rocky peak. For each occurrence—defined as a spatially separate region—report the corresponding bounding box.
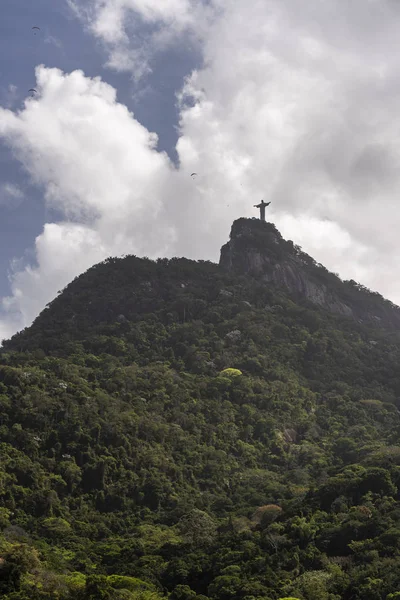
[0,220,400,600]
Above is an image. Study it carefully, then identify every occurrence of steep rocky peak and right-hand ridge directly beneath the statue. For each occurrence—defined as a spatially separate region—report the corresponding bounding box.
[220,219,400,328]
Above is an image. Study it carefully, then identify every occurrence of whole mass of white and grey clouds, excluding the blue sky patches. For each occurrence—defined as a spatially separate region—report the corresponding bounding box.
[0,0,400,340]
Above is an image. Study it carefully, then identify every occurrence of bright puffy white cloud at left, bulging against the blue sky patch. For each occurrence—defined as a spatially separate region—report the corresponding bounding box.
[0,67,175,229]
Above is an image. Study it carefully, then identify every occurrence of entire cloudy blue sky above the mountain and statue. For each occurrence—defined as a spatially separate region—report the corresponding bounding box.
[0,0,400,339]
